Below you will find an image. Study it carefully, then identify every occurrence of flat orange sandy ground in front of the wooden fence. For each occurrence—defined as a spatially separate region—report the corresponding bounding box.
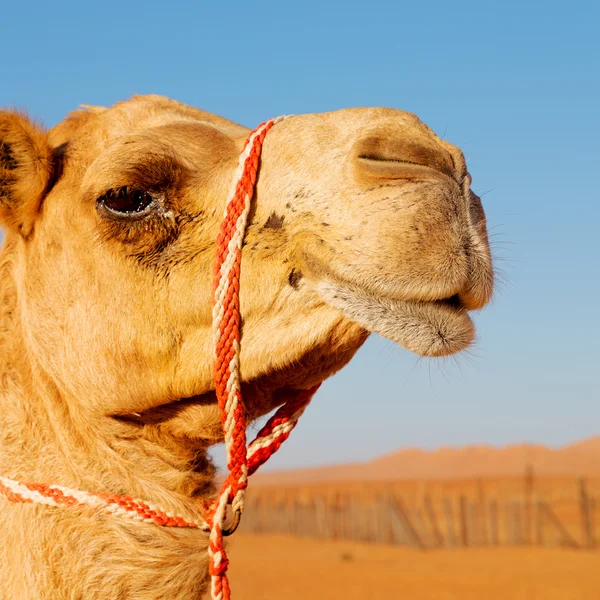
[224,534,600,600]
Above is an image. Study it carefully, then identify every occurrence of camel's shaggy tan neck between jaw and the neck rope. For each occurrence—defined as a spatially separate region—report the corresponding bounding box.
[0,241,214,517]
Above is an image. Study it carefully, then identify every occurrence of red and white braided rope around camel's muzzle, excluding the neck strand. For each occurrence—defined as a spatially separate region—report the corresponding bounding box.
[208,117,316,600]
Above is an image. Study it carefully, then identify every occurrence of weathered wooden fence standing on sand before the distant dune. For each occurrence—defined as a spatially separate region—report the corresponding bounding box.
[242,479,600,549]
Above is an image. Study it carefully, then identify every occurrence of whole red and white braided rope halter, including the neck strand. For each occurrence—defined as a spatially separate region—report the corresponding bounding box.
[0,117,319,600]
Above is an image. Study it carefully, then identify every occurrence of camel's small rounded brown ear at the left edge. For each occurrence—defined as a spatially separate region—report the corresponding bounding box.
[0,110,53,237]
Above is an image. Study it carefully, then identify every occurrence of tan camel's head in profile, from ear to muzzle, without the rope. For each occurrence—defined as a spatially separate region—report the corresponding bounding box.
[0,96,493,443]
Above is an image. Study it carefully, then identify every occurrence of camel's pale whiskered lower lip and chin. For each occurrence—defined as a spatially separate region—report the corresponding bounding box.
[317,281,475,357]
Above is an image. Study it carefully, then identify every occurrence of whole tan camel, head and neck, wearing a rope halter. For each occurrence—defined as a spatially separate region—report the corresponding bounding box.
[0,96,494,600]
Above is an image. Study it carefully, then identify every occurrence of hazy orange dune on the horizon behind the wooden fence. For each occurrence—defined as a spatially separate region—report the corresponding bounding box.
[253,436,600,485]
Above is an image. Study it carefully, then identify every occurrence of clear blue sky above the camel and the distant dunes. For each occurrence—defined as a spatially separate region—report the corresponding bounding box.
[0,0,600,467]
